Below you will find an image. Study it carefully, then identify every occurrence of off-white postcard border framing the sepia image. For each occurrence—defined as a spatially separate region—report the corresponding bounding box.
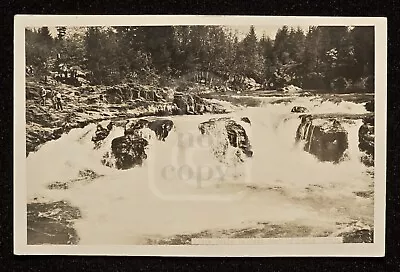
[14,15,387,257]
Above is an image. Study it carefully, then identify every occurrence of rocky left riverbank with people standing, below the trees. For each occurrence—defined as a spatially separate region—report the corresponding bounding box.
[26,81,228,156]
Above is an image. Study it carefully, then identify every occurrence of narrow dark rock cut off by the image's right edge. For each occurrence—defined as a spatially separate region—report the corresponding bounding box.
[358,116,375,166]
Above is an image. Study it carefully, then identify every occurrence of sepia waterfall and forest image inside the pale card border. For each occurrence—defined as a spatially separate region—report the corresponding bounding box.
[14,16,386,255]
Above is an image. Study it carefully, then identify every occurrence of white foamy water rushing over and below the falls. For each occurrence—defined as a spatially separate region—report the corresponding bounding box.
[27,98,373,244]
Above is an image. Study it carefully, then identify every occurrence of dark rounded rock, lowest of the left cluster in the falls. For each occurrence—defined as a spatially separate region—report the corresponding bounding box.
[102,134,148,169]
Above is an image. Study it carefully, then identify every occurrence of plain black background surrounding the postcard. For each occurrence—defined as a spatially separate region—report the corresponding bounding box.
[0,0,400,271]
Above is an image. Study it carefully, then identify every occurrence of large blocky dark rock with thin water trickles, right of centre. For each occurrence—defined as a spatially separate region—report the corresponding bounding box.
[296,115,348,163]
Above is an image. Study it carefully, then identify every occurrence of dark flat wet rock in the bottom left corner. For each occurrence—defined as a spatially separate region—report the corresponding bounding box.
[27,201,81,245]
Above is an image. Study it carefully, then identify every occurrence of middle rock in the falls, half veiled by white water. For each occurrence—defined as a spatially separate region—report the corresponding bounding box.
[199,117,253,161]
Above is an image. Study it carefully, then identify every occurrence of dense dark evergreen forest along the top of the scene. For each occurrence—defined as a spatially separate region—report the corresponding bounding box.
[25,26,374,91]
